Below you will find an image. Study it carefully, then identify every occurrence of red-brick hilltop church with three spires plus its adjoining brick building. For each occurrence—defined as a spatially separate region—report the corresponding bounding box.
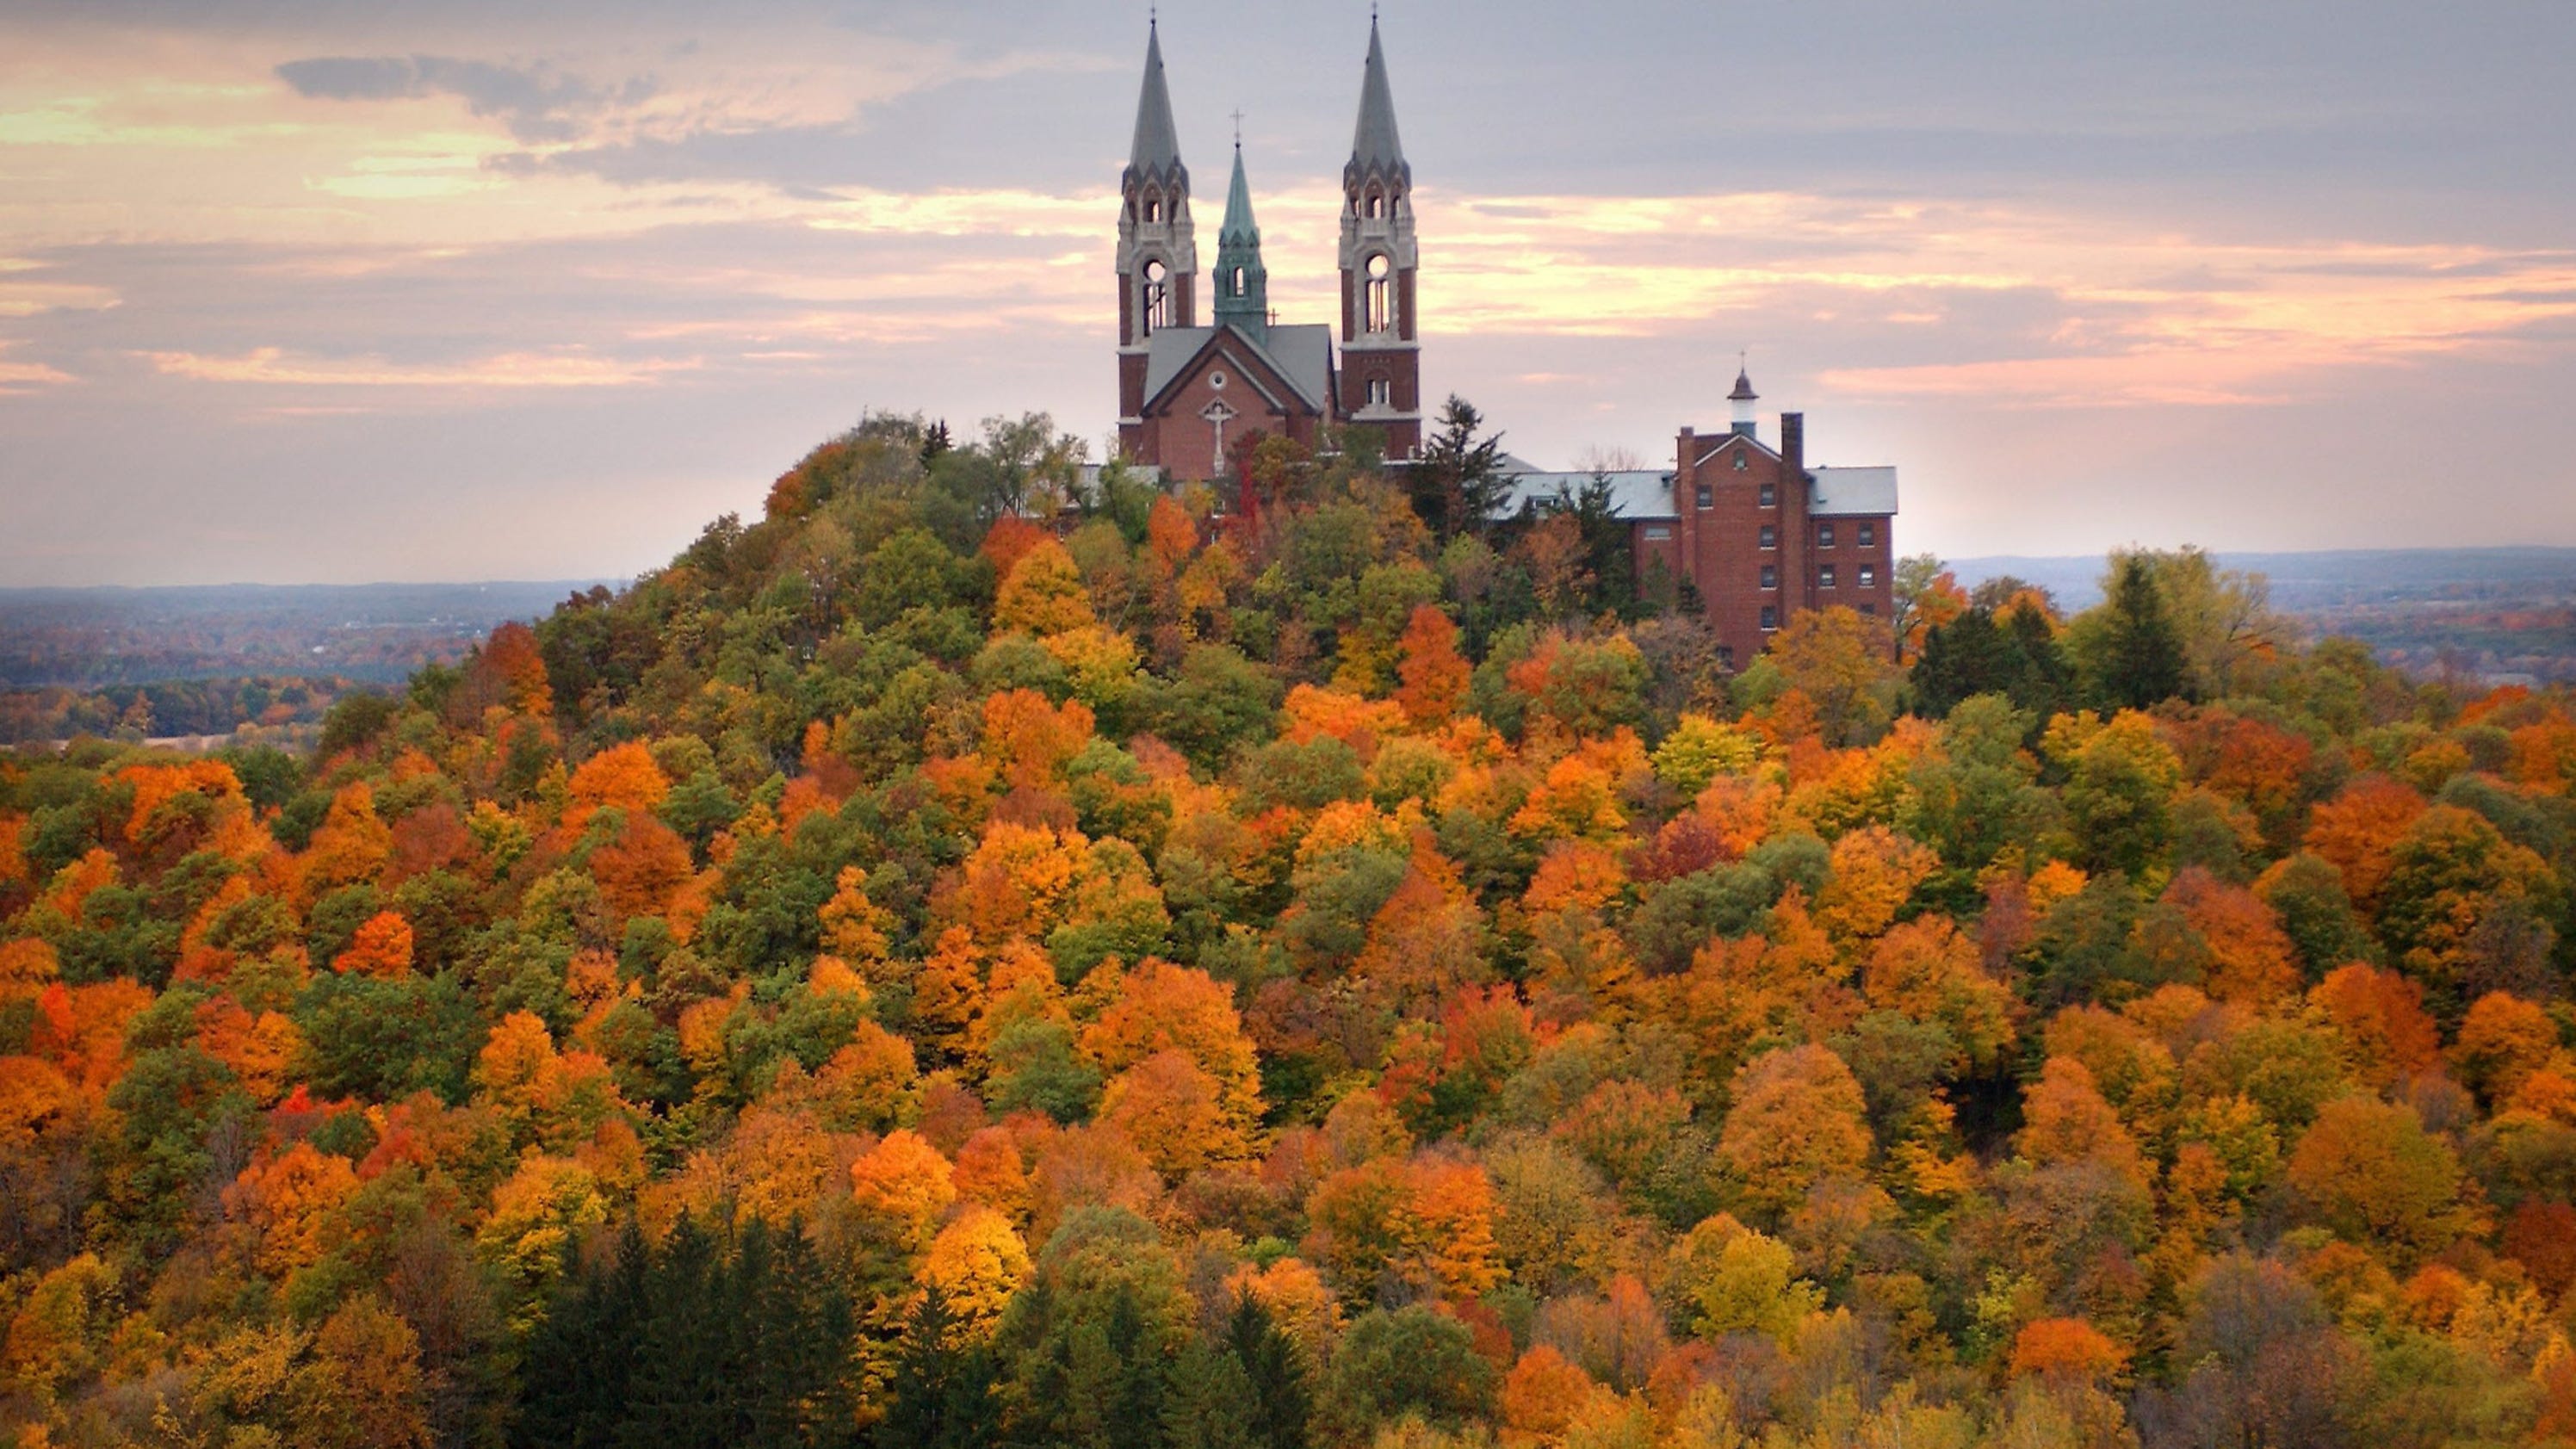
[1118,18,1896,663]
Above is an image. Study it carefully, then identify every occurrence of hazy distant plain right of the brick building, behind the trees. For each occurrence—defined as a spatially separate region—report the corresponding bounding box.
[1950,549,2576,684]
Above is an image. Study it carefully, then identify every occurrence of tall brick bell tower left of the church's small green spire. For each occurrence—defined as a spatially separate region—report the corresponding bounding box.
[1118,21,1198,451]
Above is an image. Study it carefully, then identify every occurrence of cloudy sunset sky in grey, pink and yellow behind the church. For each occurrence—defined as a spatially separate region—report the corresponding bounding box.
[0,0,2576,585]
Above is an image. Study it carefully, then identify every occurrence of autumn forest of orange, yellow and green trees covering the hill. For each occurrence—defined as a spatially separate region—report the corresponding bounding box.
[0,410,2576,1449]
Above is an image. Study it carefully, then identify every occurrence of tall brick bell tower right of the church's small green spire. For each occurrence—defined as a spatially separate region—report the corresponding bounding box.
[1340,15,1422,459]
